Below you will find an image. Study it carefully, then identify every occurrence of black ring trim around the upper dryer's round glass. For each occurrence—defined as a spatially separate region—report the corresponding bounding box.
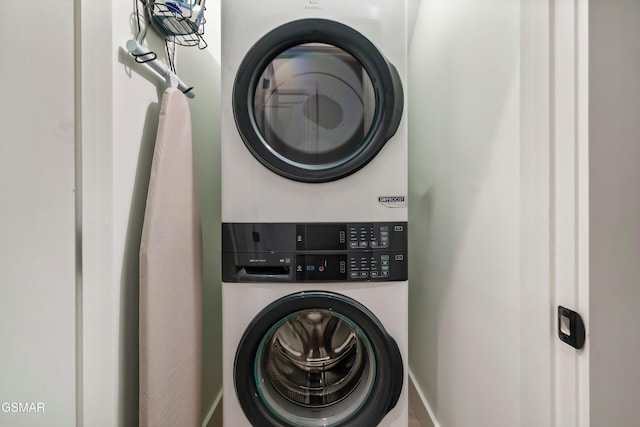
[233,19,404,183]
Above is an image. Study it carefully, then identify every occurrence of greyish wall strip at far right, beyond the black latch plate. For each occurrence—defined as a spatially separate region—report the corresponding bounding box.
[588,0,640,427]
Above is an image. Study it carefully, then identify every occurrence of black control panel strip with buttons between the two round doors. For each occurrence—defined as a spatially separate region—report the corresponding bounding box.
[222,222,407,282]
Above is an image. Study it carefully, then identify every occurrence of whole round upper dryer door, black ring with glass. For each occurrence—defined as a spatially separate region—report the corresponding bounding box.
[233,19,404,182]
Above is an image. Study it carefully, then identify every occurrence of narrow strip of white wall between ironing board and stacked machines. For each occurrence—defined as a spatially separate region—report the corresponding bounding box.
[178,0,222,426]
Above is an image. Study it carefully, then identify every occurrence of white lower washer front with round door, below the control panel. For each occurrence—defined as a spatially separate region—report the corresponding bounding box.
[222,282,408,427]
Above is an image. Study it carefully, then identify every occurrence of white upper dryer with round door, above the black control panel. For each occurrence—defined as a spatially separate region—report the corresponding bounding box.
[221,0,407,226]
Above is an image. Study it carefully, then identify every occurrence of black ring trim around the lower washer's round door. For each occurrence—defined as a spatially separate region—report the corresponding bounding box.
[234,291,404,427]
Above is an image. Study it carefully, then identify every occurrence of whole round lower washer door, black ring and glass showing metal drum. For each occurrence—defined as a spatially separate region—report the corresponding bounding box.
[234,291,403,427]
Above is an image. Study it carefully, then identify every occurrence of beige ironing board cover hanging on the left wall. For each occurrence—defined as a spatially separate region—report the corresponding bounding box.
[139,88,202,427]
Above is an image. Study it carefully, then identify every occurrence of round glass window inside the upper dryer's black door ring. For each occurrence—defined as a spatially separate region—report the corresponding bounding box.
[253,43,376,169]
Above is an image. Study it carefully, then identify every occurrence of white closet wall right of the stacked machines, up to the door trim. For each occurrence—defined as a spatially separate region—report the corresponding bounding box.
[408,0,524,427]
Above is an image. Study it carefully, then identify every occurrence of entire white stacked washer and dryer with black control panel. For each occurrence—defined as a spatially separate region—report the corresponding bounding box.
[221,0,408,427]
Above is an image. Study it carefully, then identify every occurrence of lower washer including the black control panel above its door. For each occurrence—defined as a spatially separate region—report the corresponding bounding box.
[222,222,408,427]
